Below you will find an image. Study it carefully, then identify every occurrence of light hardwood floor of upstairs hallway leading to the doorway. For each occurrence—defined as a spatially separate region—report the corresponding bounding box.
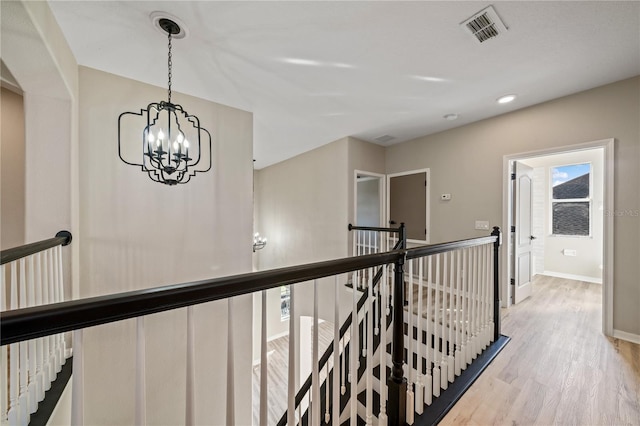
[441,276,640,426]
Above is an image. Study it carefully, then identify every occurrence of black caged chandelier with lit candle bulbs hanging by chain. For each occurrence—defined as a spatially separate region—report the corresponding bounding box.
[118,18,211,185]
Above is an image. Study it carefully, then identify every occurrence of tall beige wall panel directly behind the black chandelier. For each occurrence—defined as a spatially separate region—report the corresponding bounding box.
[79,67,253,425]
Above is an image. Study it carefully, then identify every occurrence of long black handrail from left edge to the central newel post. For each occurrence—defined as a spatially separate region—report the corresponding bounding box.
[0,251,404,345]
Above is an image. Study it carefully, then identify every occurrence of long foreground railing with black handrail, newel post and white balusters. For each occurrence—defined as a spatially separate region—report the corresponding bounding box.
[0,228,499,425]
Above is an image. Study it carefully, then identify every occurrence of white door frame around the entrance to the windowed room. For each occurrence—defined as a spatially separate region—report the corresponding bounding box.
[500,138,615,337]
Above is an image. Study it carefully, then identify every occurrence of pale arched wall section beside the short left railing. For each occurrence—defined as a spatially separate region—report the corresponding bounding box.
[0,1,80,316]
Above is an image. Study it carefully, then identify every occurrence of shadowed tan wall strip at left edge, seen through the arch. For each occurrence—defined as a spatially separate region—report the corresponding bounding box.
[0,87,25,250]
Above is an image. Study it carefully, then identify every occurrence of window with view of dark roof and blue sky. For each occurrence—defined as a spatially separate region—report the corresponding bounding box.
[551,163,591,236]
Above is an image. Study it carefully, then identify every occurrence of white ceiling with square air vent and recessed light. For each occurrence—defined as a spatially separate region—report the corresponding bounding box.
[50,0,640,168]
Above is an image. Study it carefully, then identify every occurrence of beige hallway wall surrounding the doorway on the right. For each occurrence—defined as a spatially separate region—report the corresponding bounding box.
[386,77,640,335]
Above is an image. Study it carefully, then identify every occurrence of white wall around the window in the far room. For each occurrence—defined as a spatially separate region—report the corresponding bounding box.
[524,149,604,282]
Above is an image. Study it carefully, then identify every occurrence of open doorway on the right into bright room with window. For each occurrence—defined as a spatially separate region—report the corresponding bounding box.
[501,139,614,336]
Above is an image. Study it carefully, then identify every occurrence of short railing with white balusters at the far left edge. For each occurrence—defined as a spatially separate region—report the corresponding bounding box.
[0,231,71,425]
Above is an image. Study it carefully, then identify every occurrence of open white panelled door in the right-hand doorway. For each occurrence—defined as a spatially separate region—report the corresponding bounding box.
[511,161,535,303]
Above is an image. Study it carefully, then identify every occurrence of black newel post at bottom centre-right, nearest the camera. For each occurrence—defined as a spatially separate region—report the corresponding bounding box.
[388,223,407,425]
